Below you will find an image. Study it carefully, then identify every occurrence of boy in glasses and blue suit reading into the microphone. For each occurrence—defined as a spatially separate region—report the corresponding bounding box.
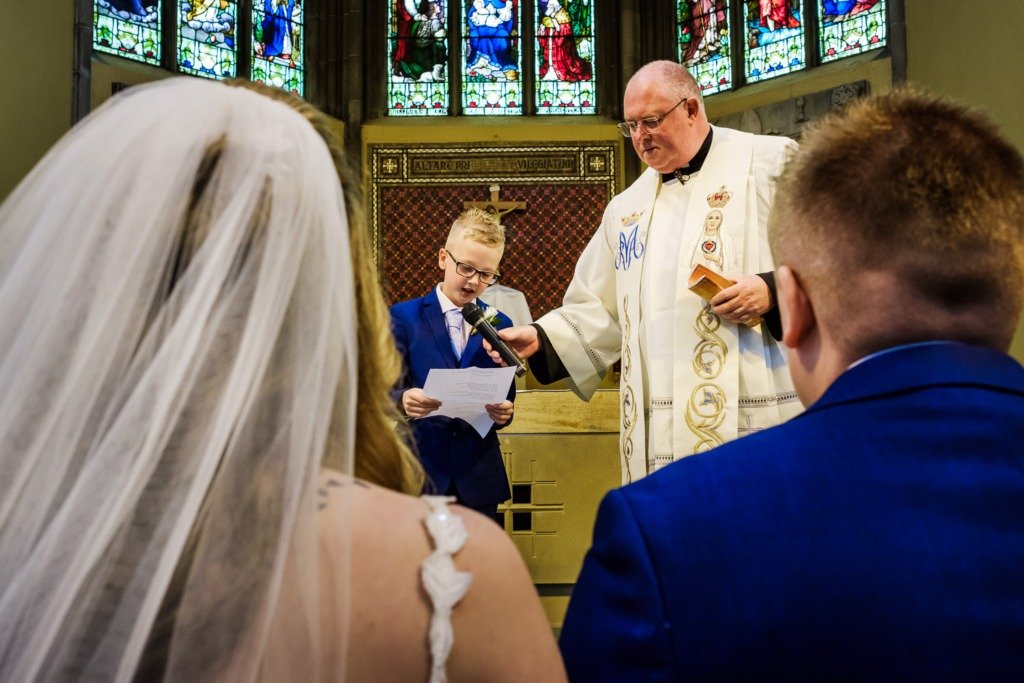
[391,209,515,519]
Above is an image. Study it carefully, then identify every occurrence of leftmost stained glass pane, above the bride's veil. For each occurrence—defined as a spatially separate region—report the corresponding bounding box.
[92,0,161,66]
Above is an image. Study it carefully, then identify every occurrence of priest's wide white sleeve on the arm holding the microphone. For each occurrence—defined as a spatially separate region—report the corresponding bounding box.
[537,209,623,400]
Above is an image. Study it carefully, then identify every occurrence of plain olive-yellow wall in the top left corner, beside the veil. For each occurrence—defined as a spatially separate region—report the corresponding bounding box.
[0,2,75,200]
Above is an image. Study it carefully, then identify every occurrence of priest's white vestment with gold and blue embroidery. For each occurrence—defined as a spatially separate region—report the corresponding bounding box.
[538,128,802,483]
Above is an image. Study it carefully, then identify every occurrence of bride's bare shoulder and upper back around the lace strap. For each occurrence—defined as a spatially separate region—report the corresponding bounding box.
[322,475,565,681]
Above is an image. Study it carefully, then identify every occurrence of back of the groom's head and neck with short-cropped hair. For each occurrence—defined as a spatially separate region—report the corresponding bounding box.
[769,90,1024,404]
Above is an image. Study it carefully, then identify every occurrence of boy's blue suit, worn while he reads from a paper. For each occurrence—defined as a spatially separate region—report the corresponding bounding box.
[391,291,515,507]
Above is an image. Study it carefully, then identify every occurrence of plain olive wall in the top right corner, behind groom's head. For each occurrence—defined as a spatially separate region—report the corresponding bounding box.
[906,0,1024,361]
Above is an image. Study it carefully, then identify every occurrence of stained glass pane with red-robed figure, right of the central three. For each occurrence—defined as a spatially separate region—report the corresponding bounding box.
[535,0,597,114]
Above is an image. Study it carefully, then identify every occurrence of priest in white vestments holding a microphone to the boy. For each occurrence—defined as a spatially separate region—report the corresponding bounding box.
[494,61,802,483]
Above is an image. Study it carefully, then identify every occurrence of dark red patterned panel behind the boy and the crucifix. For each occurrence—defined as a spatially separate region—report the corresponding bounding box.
[380,182,610,317]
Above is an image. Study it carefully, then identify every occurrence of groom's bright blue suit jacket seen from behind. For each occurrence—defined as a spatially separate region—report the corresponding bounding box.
[561,343,1024,681]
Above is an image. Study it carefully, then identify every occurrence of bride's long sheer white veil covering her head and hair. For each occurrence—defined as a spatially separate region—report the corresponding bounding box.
[0,79,356,681]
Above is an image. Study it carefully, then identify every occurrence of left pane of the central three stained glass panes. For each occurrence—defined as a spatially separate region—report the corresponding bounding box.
[387,0,450,116]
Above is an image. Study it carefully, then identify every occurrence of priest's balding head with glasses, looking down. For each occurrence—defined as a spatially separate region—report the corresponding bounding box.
[620,60,710,173]
